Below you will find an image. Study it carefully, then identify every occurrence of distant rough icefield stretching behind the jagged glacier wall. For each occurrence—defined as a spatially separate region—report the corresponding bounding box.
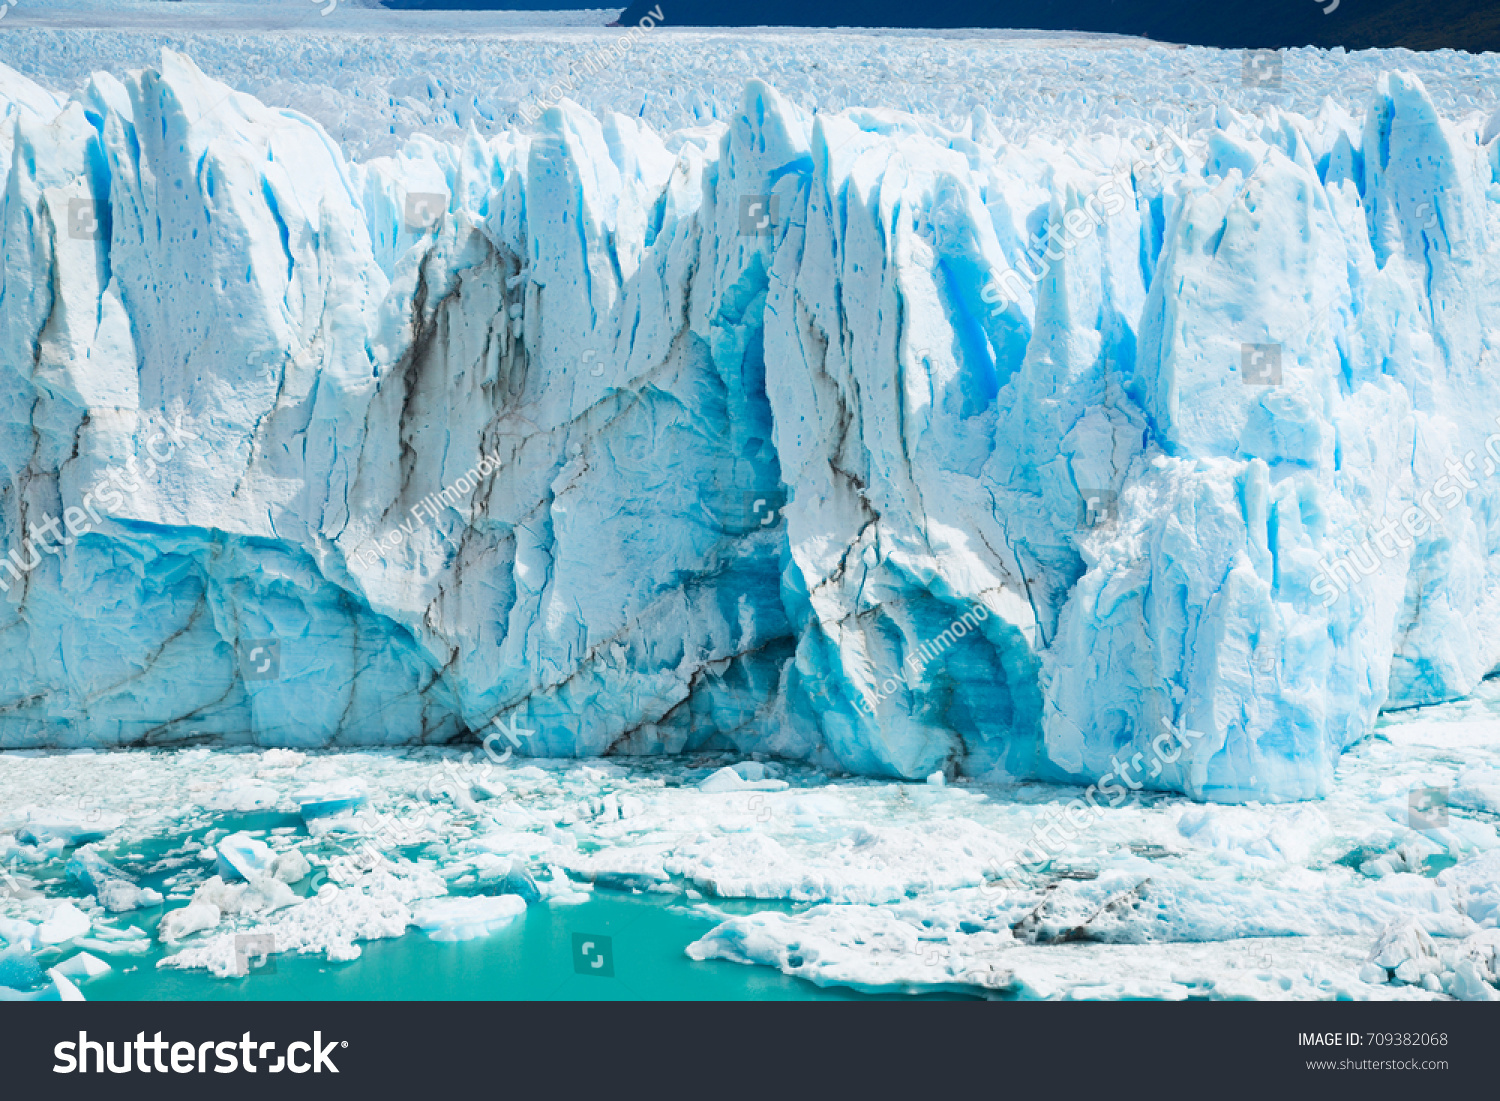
[0,8,1500,159]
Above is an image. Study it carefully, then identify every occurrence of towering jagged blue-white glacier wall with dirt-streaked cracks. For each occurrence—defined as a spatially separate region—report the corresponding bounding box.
[0,53,1500,801]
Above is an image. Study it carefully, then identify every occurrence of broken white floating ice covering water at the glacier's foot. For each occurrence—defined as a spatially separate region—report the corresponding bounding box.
[0,693,1500,999]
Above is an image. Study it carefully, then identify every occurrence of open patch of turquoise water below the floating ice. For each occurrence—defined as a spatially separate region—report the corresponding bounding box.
[83,891,960,1002]
